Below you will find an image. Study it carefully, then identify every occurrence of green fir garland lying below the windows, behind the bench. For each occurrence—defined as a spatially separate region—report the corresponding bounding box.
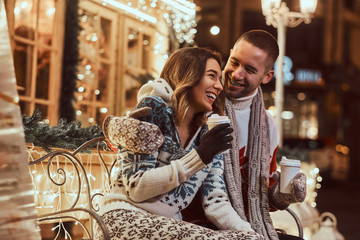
[22,111,105,152]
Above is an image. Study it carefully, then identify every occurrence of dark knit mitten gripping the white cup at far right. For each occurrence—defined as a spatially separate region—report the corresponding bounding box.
[269,172,306,210]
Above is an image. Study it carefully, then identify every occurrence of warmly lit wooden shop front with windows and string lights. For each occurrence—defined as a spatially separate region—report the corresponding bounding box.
[5,0,196,126]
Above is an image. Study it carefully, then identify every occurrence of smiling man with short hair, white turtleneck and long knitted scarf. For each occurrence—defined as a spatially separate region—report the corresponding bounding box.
[219,30,306,239]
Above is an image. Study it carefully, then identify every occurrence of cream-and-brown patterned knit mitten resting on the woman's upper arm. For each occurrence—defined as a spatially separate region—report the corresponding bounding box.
[103,107,165,154]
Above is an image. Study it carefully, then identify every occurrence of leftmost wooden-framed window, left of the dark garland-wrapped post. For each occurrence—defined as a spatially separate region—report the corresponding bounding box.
[5,0,64,123]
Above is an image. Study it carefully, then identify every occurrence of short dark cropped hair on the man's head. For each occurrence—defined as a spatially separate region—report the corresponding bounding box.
[235,29,279,67]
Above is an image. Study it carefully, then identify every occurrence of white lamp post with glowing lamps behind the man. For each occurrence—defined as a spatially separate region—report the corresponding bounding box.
[261,0,317,147]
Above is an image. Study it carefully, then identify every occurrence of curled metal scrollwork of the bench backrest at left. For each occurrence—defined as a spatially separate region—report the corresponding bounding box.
[29,137,116,239]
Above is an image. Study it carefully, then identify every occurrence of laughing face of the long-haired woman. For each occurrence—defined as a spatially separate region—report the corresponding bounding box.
[190,58,223,113]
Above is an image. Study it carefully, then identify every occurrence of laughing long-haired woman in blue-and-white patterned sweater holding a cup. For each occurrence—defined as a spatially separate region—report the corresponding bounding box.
[100,48,263,239]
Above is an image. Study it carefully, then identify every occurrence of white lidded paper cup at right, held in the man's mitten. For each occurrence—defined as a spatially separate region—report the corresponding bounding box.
[280,156,301,193]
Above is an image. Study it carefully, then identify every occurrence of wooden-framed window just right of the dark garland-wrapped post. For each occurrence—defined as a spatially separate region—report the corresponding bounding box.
[75,1,117,126]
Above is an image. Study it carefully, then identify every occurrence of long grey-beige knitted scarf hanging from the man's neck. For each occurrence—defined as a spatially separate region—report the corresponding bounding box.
[224,87,278,240]
